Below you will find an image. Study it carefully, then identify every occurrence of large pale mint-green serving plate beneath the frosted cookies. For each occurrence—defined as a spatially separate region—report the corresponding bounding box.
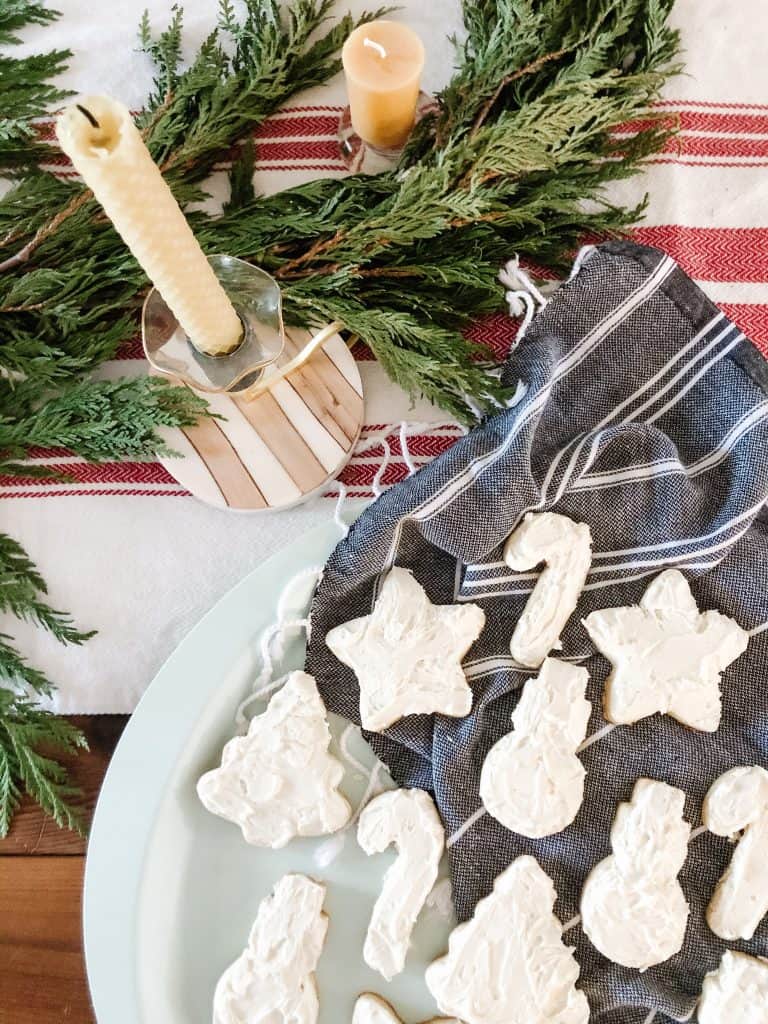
[84,525,451,1024]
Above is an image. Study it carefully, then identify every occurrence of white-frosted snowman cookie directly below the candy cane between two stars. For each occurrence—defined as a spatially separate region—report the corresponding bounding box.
[480,657,591,839]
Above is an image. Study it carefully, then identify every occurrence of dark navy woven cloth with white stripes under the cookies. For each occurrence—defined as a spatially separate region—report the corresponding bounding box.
[307,243,768,1024]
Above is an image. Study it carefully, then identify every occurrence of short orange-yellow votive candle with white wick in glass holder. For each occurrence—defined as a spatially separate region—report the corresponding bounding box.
[341,22,424,150]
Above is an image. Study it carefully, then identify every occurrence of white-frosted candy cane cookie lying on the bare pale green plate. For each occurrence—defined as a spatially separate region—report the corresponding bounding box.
[357,790,445,981]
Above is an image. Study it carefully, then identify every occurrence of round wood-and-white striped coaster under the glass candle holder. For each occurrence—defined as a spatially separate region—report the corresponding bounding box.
[156,331,364,511]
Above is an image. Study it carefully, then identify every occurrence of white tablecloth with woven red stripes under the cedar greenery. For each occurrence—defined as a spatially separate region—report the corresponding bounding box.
[0,0,768,713]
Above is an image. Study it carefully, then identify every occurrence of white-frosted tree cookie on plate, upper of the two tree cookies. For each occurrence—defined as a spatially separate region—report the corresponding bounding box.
[198,672,351,849]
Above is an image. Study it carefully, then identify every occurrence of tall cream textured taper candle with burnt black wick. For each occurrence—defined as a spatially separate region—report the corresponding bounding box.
[56,96,243,355]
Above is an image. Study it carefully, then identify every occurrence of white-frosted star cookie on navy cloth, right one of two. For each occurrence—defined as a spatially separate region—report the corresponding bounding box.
[584,569,750,732]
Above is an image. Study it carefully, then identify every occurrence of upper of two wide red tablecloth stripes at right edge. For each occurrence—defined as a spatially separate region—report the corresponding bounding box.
[632,224,768,282]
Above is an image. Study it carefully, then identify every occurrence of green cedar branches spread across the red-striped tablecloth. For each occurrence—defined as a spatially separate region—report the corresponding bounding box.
[0,0,678,831]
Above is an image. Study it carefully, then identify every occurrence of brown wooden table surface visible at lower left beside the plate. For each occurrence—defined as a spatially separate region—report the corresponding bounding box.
[0,715,128,1024]
